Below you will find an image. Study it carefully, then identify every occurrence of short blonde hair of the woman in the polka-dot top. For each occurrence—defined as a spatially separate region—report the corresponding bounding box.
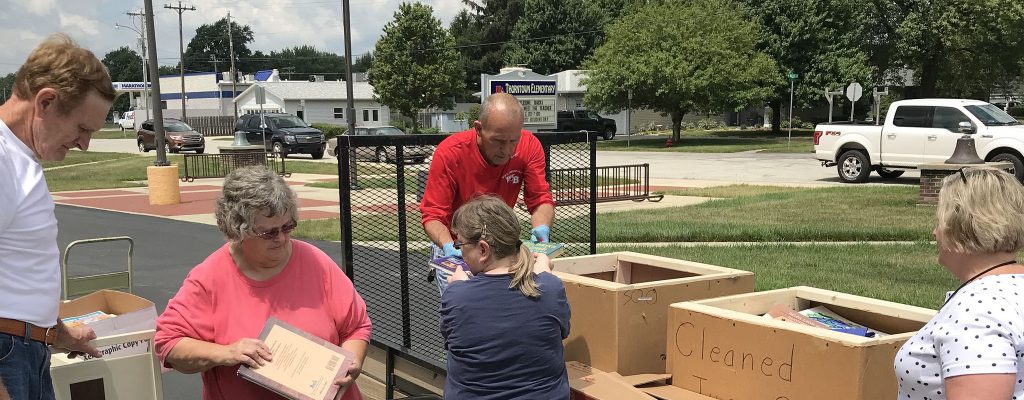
[936,168,1024,254]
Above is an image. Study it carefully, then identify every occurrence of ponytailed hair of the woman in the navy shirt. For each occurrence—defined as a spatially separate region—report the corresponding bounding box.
[452,195,541,298]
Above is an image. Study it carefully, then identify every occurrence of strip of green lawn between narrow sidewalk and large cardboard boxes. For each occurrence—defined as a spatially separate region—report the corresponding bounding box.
[600,243,957,309]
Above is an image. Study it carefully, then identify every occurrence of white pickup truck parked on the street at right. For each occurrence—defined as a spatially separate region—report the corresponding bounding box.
[814,98,1024,182]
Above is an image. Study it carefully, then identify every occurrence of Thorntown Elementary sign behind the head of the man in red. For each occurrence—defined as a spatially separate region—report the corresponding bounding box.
[481,70,558,130]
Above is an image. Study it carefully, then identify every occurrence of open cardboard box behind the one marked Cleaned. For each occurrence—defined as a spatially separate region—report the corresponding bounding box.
[552,252,754,375]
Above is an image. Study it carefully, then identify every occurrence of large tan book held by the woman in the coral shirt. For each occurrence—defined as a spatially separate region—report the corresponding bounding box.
[238,316,354,400]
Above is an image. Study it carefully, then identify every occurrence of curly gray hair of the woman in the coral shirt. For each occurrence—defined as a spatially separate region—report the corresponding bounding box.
[216,166,299,241]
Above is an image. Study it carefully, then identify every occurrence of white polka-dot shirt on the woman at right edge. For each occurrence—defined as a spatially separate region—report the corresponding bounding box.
[895,274,1024,400]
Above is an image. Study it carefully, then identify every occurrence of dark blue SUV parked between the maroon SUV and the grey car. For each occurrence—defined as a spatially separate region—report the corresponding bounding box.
[234,114,327,160]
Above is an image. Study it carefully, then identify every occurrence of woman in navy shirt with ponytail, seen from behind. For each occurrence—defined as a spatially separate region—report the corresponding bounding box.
[440,195,569,400]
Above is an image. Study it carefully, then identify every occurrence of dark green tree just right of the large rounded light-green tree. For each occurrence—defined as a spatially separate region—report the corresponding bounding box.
[742,0,881,133]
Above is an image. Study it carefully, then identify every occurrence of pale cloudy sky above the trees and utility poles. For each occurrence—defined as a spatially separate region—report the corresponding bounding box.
[0,0,464,76]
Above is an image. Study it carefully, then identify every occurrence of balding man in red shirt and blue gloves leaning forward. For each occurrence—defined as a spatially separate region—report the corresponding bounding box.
[420,93,555,263]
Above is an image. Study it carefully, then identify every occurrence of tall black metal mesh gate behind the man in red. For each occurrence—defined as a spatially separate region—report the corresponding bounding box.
[338,132,598,398]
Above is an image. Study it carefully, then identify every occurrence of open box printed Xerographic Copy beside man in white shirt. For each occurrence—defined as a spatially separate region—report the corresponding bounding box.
[50,291,163,400]
